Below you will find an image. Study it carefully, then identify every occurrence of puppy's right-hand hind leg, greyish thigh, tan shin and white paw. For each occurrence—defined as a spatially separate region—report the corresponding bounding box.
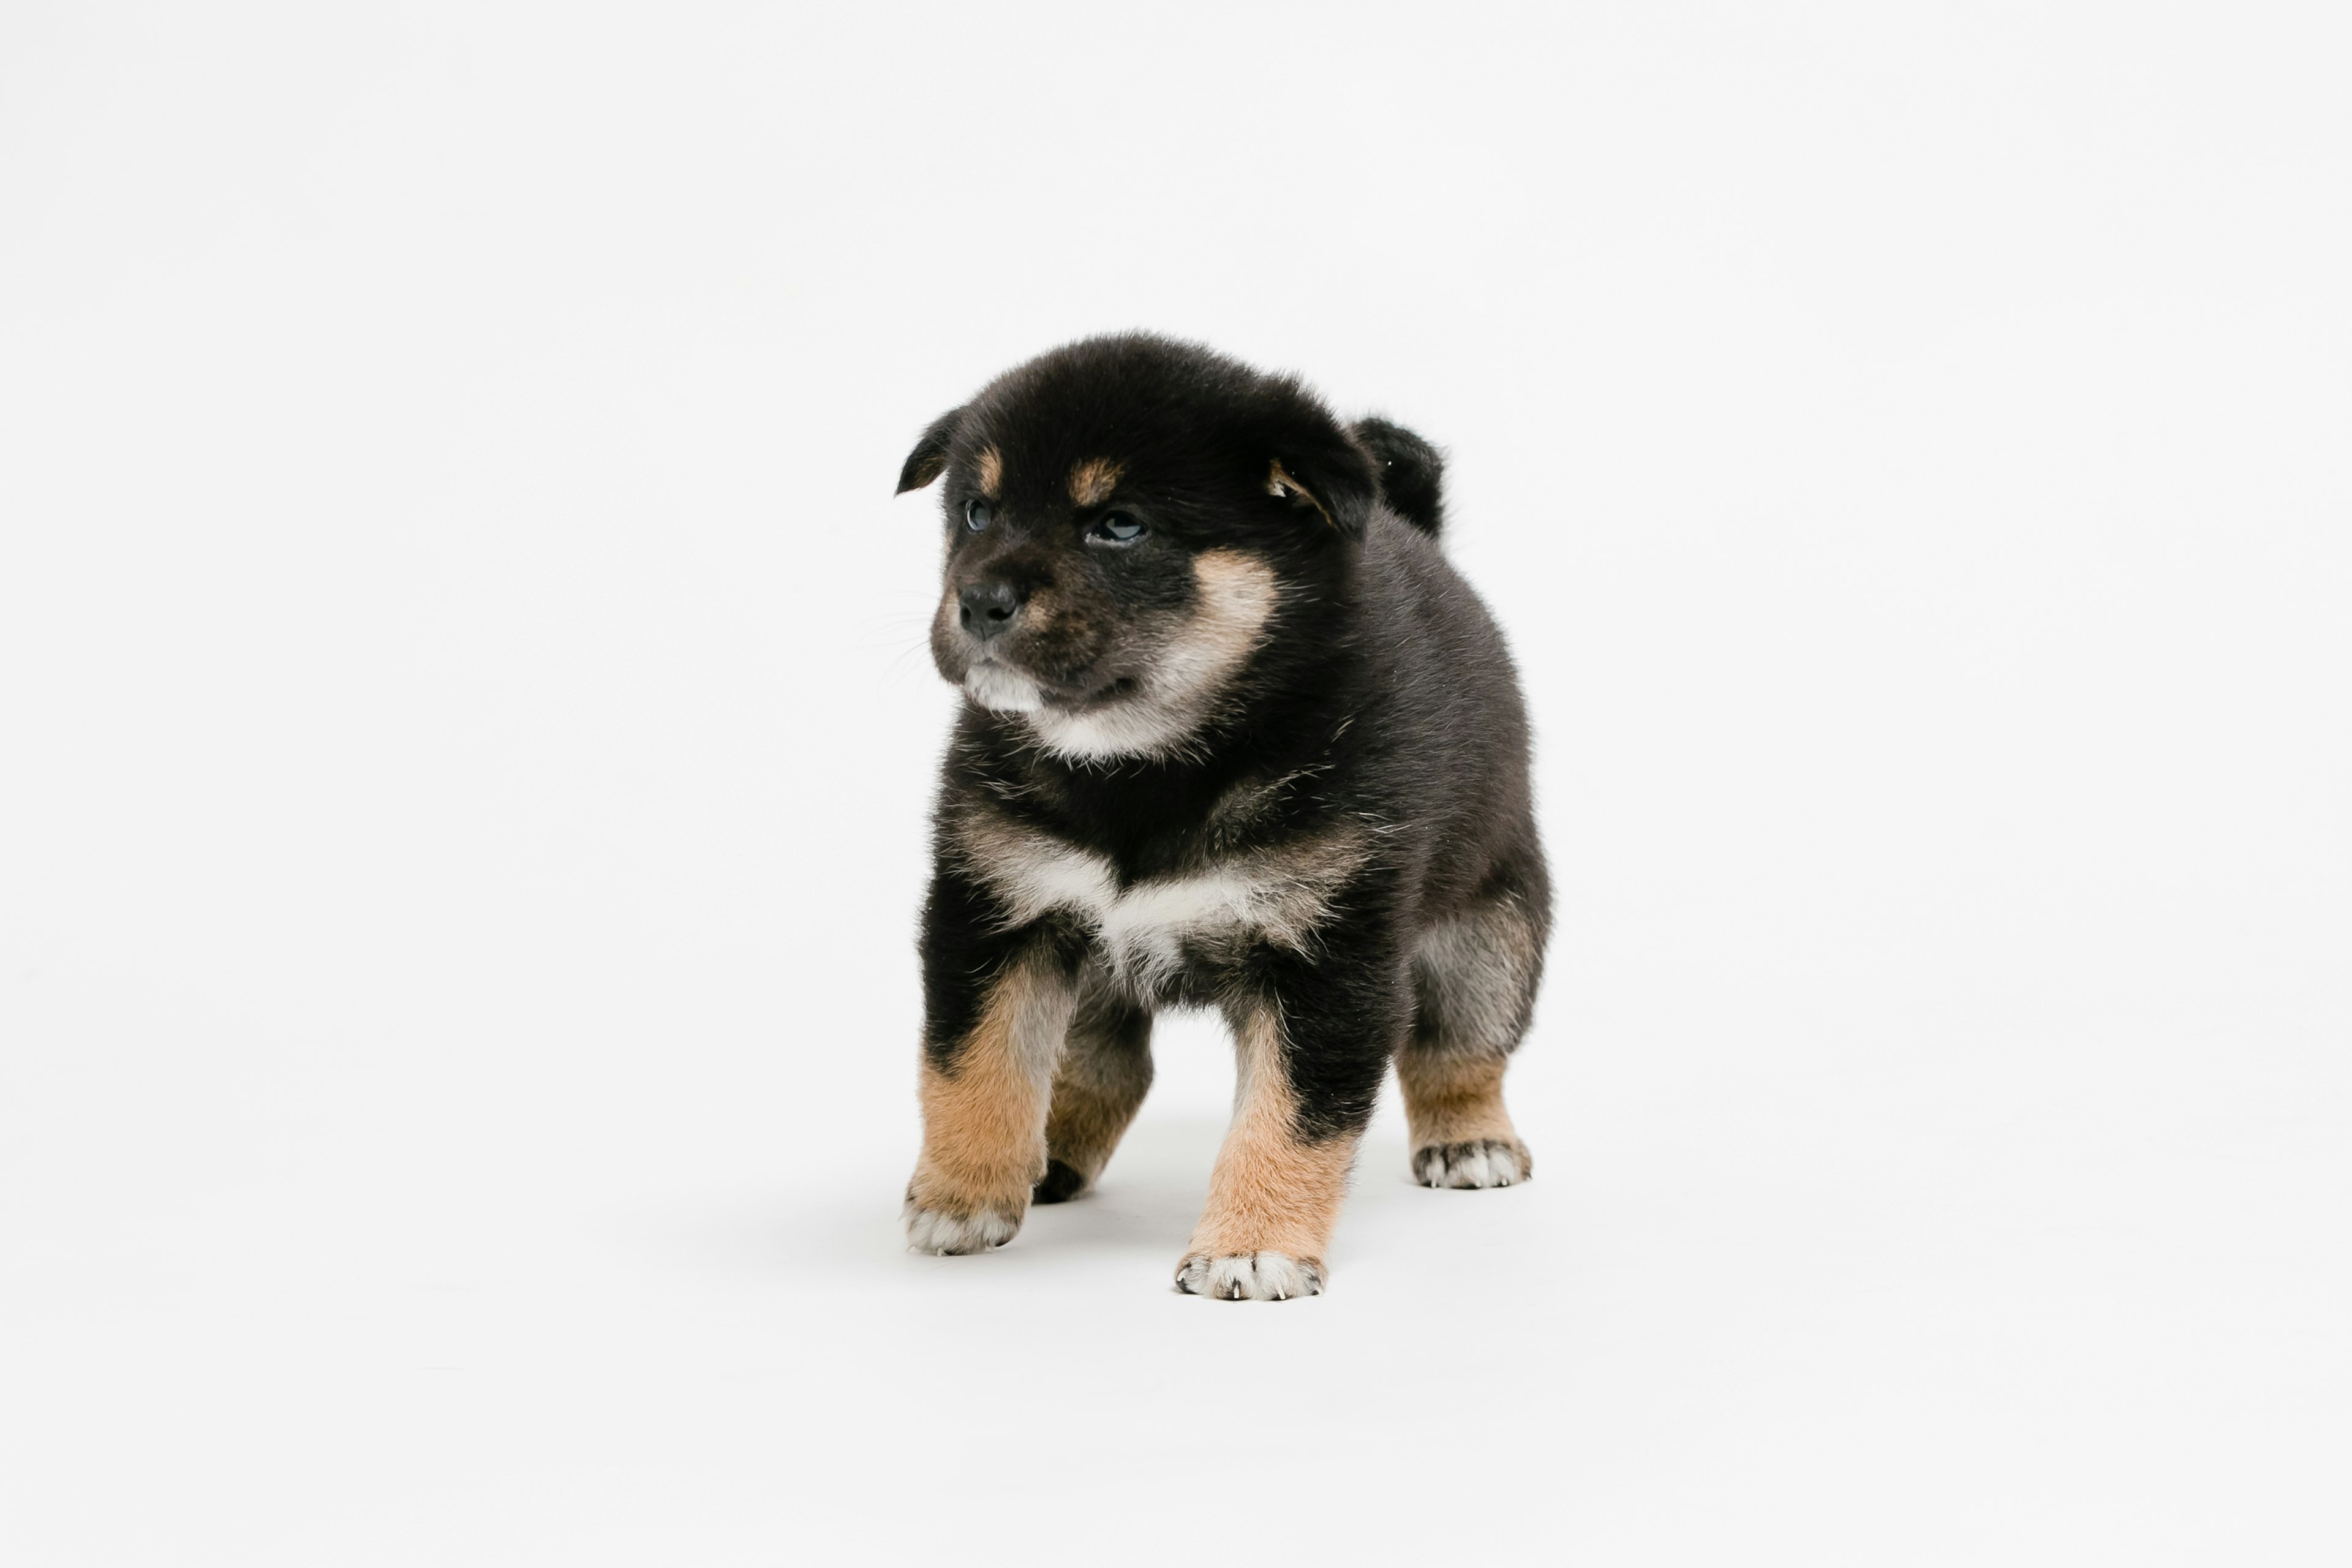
[1397,898,1543,1187]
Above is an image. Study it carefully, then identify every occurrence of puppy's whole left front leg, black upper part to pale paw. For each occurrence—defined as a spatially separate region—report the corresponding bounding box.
[905,898,1077,1253]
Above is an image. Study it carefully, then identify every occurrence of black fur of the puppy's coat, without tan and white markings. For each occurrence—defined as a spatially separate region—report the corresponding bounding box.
[899,336,1550,1232]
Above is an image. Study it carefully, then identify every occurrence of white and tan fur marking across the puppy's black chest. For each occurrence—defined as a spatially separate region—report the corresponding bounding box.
[955,816,1364,990]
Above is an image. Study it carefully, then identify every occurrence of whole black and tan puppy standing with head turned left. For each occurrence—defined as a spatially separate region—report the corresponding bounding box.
[899,336,1550,1300]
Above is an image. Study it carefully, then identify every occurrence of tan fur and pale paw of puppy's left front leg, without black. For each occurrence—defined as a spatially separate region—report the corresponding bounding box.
[905,959,1075,1253]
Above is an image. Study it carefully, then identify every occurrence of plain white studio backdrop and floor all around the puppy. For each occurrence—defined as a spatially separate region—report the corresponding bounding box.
[0,0,2352,1566]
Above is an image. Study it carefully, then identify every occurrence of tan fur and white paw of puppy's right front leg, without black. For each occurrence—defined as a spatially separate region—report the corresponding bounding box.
[1178,1006,1357,1300]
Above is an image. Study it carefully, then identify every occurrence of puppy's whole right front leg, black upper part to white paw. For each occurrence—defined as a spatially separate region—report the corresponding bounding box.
[1176,997,1392,1300]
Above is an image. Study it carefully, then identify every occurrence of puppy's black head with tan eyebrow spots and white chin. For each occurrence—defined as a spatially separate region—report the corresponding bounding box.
[899,336,1381,757]
